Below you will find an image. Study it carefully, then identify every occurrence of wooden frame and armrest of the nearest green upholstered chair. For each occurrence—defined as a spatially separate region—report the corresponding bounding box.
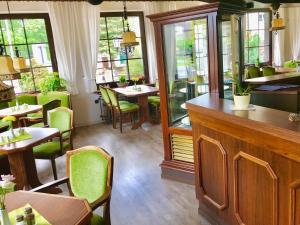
[31,146,114,225]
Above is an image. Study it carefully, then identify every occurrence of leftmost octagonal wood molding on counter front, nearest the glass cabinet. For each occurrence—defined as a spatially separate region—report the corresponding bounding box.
[197,135,228,210]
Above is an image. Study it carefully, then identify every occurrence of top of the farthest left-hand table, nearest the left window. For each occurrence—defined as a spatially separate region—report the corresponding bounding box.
[0,105,43,118]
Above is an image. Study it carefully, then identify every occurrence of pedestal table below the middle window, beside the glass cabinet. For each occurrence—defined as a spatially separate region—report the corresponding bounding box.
[114,85,159,129]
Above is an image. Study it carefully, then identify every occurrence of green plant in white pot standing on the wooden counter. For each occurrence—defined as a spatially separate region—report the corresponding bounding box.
[232,76,251,109]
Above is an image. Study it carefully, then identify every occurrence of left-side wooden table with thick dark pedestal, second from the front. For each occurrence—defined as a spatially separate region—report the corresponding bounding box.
[0,127,60,190]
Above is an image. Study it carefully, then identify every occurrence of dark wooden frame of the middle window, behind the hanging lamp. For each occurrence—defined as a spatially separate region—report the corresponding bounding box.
[97,11,149,85]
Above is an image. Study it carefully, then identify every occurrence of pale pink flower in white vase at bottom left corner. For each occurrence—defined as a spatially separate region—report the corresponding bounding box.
[0,175,15,225]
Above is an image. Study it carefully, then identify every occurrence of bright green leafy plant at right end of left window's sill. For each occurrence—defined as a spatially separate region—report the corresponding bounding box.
[39,72,67,94]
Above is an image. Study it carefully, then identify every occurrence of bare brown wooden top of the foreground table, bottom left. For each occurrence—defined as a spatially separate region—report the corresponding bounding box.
[5,191,92,225]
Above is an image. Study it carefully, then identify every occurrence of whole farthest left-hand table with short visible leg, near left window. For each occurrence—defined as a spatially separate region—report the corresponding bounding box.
[0,104,43,127]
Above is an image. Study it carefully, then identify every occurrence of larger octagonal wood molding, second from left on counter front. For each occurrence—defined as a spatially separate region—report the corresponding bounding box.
[233,151,278,225]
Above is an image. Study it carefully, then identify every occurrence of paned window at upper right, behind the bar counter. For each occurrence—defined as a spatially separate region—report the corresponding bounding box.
[245,11,272,64]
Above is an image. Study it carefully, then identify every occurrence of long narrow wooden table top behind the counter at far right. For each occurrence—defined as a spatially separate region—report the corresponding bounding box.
[245,72,300,84]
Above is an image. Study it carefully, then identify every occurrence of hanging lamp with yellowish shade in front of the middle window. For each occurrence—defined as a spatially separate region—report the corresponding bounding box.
[121,1,139,55]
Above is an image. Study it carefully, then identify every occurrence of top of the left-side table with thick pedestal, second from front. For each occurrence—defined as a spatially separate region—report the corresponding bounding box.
[0,127,60,155]
